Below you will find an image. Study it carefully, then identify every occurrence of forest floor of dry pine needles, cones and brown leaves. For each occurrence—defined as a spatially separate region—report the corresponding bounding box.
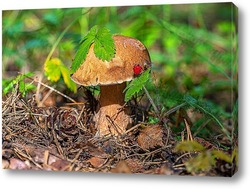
[2,83,237,176]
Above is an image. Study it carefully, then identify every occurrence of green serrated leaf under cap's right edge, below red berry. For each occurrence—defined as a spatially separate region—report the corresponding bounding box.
[124,69,150,102]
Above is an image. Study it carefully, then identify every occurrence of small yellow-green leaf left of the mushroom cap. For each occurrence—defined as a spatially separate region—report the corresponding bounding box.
[44,58,62,82]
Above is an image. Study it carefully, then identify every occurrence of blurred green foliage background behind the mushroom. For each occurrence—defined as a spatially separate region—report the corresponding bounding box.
[2,3,238,142]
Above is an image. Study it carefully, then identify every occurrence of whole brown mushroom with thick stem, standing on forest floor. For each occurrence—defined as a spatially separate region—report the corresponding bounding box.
[71,35,151,137]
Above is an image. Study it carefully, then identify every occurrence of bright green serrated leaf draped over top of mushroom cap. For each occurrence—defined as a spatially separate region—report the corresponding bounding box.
[71,26,115,73]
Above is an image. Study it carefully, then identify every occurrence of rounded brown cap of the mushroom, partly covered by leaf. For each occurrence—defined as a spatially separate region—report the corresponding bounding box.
[71,35,151,86]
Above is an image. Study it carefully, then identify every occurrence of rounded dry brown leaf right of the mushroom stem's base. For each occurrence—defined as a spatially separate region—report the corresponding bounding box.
[137,125,164,150]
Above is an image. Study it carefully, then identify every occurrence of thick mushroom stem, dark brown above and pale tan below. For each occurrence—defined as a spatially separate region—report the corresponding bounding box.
[94,83,131,136]
